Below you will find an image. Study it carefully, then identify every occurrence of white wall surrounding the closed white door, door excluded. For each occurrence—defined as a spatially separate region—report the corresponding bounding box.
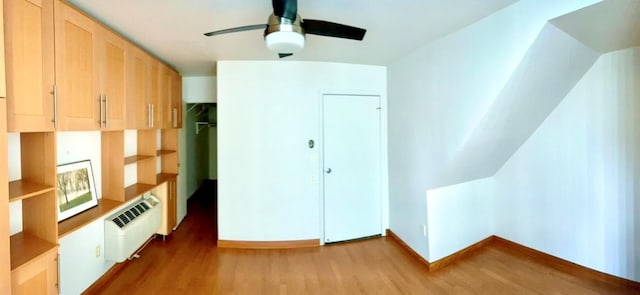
[217,61,387,241]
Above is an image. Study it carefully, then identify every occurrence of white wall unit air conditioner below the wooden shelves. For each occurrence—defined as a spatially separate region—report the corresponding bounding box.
[104,195,162,262]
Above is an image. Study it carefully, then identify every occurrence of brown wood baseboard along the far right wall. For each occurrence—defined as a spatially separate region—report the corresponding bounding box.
[492,236,640,289]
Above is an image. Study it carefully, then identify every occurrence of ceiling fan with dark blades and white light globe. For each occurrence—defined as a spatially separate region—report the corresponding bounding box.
[204,0,367,58]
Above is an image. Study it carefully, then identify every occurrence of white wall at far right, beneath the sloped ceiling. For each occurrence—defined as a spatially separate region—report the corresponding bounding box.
[495,48,640,281]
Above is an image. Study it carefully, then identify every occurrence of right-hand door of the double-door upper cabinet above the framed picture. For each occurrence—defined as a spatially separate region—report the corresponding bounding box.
[97,27,126,130]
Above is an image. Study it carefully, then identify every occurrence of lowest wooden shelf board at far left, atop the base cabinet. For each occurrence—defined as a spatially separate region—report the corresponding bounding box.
[10,232,58,271]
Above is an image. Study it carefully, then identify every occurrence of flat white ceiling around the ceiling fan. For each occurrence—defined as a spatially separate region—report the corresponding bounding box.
[68,0,516,76]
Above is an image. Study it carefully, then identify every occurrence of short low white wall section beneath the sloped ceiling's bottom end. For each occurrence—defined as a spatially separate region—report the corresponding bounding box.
[427,177,495,261]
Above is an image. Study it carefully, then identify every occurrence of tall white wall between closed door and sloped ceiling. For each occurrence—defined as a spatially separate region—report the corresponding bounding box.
[388,0,598,264]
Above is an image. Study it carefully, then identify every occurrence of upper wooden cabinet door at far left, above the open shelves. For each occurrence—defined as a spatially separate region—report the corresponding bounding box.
[4,0,55,132]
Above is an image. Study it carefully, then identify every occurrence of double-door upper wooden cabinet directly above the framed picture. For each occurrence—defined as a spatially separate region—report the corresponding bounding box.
[55,1,126,130]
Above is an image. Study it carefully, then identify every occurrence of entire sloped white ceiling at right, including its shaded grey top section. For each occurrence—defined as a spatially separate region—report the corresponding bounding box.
[440,0,640,188]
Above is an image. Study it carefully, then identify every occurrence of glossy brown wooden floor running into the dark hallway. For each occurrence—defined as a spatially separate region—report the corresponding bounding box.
[87,184,640,294]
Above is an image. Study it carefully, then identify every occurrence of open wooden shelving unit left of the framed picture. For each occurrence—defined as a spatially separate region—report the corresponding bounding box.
[8,132,58,292]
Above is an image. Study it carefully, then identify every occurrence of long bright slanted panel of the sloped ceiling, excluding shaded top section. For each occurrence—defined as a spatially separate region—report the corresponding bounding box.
[441,24,599,184]
